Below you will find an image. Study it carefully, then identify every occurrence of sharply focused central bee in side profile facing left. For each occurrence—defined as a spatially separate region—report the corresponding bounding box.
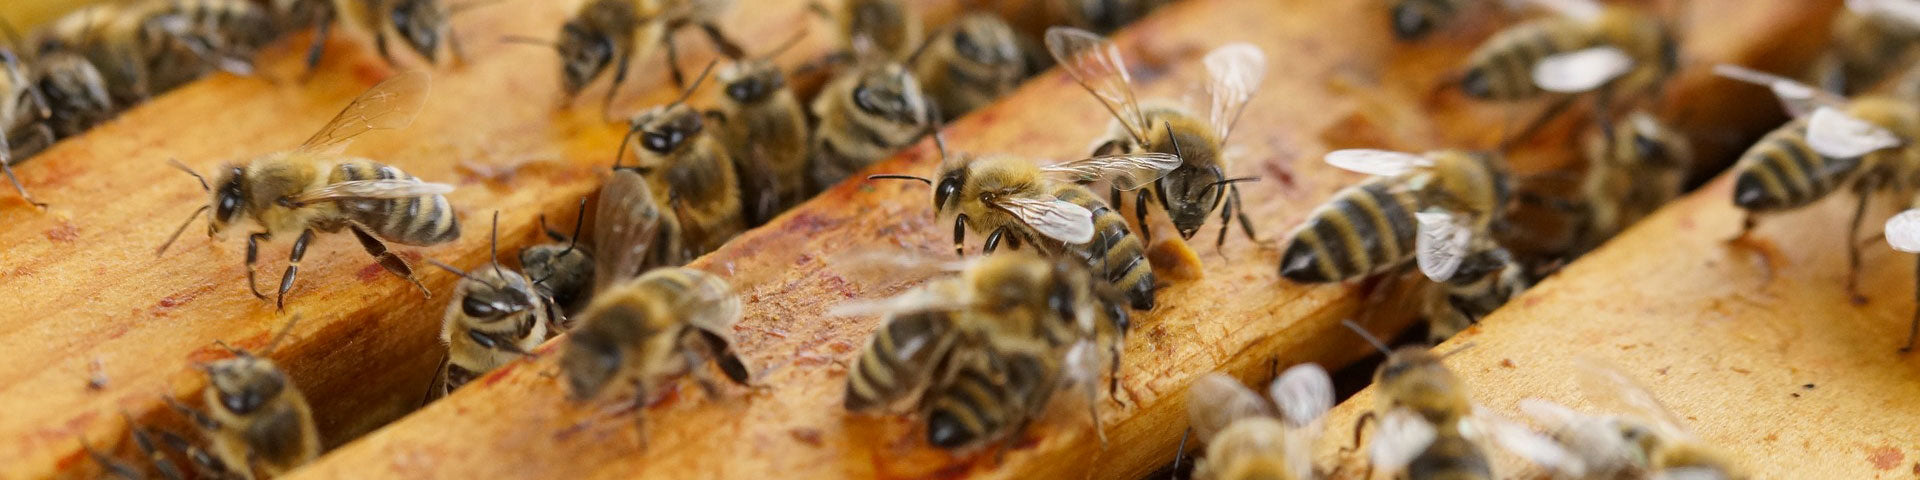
[868,132,1179,309]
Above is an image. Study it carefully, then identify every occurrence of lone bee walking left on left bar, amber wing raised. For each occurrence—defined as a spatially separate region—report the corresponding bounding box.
[156,71,461,307]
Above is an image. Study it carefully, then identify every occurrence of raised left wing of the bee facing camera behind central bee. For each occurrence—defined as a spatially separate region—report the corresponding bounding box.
[1046,27,1146,140]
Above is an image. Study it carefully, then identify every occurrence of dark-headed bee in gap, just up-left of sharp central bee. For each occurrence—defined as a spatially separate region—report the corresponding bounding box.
[808,61,939,192]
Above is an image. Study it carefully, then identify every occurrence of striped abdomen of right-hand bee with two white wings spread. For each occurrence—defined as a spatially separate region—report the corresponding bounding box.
[1281,177,1421,282]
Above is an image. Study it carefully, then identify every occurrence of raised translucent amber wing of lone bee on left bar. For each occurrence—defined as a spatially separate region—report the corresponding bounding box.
[298,71,430,152]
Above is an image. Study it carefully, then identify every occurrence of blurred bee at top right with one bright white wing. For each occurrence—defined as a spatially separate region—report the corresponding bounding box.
[1459,0,1680,104]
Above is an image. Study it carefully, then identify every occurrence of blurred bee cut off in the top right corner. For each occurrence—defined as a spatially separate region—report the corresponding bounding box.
[1812,0,1920,94]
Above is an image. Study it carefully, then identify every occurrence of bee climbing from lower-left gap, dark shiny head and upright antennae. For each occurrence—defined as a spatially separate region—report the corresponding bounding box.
[428,211,557,397]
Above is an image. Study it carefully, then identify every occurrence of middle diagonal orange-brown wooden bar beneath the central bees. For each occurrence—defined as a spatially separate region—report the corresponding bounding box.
[280,0,1836,478]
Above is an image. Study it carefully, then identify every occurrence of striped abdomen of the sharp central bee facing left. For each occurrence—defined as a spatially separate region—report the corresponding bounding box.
[1052,182,1154,309]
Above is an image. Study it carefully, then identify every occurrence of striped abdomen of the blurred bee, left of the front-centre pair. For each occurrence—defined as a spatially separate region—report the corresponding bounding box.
[845,311,952,411]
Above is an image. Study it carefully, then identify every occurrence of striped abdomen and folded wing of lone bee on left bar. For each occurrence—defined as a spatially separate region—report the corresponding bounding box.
[326,159,461,246]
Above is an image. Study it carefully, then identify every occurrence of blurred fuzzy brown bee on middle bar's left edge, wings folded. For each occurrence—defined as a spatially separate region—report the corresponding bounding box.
[561,267,747,407]
